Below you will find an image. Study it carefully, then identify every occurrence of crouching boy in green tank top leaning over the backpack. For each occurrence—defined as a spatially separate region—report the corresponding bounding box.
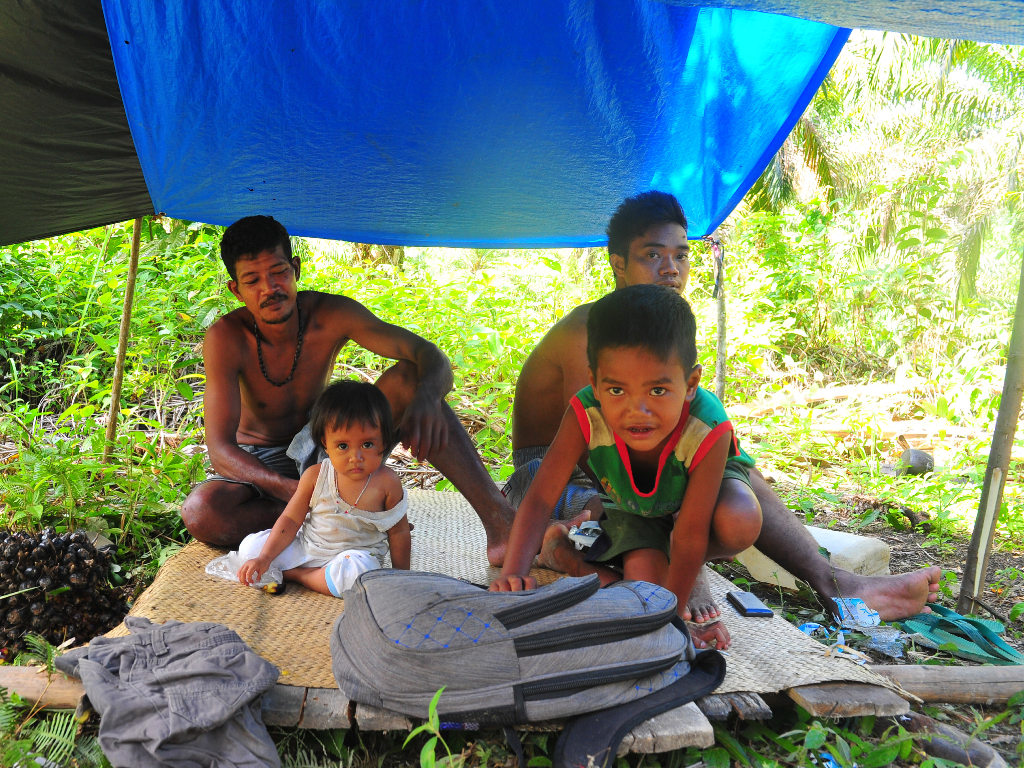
[490,285,761,649]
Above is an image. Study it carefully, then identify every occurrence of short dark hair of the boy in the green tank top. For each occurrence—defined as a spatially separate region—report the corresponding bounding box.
[587,285,697,374]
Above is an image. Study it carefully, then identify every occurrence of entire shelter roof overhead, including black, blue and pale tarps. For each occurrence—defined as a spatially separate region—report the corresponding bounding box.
[0,0,1024,246]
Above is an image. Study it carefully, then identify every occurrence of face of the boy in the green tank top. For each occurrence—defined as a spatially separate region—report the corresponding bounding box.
[590,347,700,452]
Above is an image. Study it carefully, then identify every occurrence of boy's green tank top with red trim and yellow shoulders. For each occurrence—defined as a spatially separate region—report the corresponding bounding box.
[569,386,754,517]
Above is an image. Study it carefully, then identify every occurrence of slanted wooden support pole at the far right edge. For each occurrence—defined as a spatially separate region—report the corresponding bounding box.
[956,250,1024,613]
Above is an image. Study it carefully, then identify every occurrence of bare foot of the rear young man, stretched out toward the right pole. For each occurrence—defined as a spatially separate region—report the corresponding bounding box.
[818,565,942,622]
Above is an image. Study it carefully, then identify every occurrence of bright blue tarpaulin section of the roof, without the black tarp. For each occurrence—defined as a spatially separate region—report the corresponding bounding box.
[102,0,849,247]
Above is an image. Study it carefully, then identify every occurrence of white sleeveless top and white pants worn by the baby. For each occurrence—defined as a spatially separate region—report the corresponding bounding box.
[239,459,409,597]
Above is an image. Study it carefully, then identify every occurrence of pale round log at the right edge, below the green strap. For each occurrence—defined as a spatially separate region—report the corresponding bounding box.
[869,665,1024,705]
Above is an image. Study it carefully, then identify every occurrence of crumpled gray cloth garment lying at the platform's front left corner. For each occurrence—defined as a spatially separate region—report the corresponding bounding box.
[56,616,281,768]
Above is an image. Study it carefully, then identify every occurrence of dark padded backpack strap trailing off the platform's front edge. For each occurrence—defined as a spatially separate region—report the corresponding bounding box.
[552,634,725,768]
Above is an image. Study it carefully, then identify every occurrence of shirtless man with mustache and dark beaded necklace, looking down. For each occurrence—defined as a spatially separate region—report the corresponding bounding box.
[181,216,514,565]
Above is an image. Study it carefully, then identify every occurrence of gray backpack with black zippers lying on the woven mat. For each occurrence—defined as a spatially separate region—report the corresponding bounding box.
[331,570,724,729]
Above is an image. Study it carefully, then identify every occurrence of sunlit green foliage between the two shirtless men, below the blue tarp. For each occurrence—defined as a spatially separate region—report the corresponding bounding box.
[304,244,612,468]
